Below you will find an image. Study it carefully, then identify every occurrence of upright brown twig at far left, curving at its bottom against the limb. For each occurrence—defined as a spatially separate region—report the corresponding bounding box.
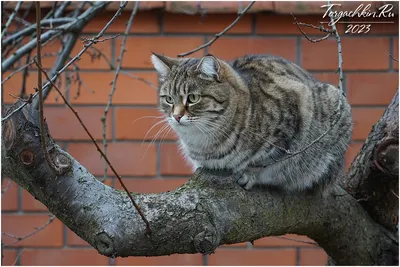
[35,1,60,174]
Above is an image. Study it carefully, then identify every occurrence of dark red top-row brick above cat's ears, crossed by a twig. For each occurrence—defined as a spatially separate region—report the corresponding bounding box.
[164,13,252,34]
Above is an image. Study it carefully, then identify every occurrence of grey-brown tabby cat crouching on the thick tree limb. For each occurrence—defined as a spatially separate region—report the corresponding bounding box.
[151,54,352,191]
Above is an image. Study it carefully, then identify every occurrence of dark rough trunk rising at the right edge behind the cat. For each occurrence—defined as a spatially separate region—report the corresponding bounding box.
[345,91,399,231]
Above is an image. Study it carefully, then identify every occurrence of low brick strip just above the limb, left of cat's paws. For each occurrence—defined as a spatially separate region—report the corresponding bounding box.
[115,178,188,194]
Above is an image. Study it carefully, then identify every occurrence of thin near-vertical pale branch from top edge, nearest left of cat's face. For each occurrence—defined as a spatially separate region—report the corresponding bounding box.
[100,1,139,182]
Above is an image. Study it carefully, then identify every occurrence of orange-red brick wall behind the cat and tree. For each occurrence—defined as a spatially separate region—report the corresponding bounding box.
[2,11,399,265]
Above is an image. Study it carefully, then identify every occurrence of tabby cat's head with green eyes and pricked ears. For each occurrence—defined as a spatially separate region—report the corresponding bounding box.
[151,54,235,136]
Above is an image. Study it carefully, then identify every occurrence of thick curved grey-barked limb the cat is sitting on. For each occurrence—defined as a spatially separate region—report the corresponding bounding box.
[2,93,398,265]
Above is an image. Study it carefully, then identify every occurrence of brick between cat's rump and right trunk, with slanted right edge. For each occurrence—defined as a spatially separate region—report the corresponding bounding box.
[352,108,385,140]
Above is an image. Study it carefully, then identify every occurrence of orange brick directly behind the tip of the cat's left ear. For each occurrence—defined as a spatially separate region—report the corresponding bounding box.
[116,36,204,69]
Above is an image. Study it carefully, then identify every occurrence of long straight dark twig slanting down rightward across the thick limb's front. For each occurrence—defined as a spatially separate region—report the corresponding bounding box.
[36,62,151,235]
